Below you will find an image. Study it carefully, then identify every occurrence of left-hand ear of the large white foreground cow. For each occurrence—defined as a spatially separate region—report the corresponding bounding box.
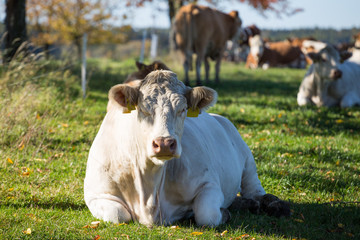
[109,81,141,113]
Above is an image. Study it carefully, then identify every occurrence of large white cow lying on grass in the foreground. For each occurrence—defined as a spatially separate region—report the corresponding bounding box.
[84,70,290,226]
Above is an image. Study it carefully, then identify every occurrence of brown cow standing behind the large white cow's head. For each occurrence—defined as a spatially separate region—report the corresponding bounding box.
[172,4,241,85]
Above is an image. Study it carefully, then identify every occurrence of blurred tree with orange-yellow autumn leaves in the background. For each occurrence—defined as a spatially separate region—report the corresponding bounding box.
[27,0,114,58]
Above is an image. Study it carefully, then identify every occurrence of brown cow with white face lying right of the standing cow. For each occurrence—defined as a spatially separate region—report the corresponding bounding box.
[245,35,306,69]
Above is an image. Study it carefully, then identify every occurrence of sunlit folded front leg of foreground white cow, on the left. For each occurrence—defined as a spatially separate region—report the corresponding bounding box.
[86,196,132,223]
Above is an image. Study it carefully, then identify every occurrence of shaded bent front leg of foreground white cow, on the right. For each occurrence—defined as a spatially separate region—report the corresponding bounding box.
[193,188,230,227]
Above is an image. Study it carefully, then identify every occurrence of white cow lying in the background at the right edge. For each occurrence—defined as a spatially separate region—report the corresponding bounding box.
[297,44,360,107]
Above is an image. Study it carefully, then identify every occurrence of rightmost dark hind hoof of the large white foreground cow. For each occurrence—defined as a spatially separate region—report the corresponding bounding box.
[260,194,291,217]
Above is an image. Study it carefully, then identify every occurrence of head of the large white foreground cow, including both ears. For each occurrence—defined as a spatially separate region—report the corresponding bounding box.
[109,70,217,164]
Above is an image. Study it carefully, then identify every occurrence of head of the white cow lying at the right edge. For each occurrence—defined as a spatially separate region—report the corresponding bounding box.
[308,45,342,80]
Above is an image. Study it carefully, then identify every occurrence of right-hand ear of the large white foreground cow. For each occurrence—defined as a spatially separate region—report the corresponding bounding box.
[185,87,217,116]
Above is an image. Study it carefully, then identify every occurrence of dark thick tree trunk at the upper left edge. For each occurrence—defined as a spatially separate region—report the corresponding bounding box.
[4,0,27,63]
